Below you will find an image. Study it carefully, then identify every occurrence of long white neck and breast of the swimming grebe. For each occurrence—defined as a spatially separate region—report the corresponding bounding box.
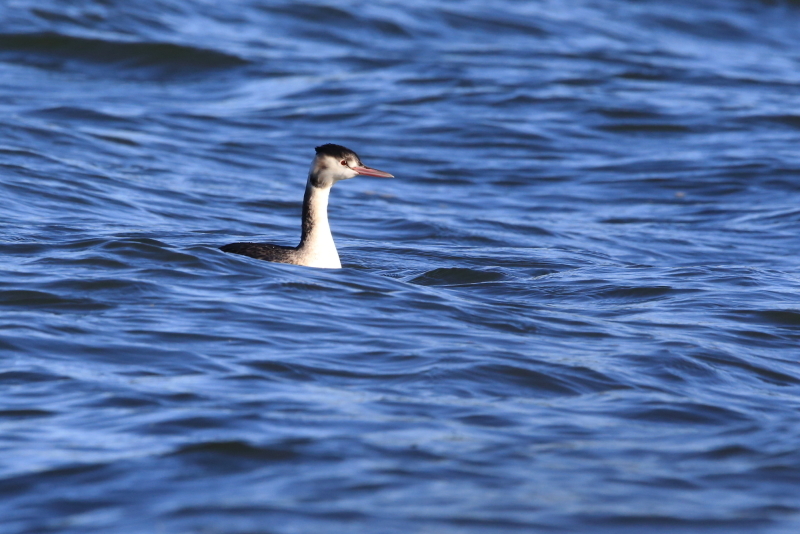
[297,179,342,269]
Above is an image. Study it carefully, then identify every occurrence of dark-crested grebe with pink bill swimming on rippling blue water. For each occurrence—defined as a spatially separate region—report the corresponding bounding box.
[220,144,392,269]
